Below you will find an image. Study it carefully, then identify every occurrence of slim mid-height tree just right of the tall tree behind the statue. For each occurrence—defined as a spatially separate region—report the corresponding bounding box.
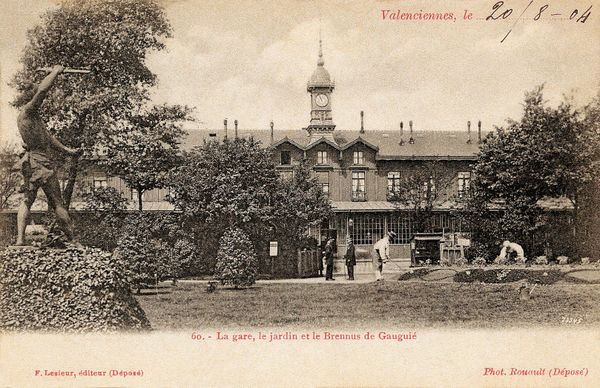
[100,105,191,211]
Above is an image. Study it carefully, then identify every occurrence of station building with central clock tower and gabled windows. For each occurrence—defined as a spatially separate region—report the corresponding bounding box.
[187,39,484,270]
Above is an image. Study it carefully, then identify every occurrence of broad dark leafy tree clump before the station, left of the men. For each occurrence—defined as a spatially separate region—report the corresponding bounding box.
[169,139,330,271]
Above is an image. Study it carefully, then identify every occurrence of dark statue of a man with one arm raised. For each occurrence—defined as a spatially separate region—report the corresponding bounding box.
[17,65,80,245]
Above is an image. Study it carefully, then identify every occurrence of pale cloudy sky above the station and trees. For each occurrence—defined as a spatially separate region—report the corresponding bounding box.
[0,0,600,141]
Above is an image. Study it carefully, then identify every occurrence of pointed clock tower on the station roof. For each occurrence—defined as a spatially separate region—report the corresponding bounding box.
[306,39,335,141]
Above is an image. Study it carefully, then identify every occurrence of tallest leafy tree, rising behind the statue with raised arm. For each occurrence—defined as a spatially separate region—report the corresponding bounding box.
[11,0,172,205]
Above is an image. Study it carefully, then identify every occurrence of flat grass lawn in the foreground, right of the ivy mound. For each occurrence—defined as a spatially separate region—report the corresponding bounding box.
[137,281,600,330]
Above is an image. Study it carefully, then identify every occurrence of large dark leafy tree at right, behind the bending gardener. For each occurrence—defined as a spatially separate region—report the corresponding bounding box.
[473,86,600,253]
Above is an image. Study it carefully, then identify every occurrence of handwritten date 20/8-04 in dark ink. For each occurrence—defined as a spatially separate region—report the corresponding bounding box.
[485,0,592,42]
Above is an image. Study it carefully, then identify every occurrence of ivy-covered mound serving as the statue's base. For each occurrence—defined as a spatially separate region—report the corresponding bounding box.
[0,246,150,332]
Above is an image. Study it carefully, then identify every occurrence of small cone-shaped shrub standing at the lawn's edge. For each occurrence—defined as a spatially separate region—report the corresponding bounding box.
[215,228,258,288]
